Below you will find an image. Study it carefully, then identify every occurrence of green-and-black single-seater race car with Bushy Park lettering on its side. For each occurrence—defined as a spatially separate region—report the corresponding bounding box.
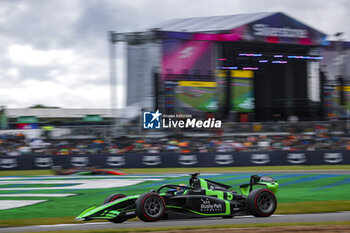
[76,173,278,223]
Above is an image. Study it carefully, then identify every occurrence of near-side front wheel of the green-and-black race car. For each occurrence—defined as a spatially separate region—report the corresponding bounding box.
[136,193,166,222]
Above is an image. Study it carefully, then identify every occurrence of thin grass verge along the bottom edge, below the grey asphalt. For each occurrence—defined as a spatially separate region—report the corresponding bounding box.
[17,221,350,233]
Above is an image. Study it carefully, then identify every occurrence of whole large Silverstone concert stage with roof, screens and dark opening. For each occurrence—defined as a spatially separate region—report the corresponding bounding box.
[114,12,340,121]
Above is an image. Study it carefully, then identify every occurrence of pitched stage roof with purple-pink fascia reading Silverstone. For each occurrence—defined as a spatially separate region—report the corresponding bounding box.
[150,12,328,45]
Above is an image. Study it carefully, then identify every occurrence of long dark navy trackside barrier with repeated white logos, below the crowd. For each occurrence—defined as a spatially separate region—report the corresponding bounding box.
[0,150,350,170]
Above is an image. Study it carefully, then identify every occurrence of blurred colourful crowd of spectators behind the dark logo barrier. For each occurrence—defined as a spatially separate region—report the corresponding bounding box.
[0,131,350,156]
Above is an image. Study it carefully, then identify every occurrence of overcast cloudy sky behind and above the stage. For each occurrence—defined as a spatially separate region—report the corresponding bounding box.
[0,0,350,108]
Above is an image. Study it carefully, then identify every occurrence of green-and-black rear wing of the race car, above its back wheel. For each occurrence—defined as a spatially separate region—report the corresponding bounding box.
[239,175,278,196]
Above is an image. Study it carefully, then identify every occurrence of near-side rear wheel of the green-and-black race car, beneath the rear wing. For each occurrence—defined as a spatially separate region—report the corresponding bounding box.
[247,189,277,217]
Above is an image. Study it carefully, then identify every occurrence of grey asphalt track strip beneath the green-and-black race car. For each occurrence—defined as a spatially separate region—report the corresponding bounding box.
[0,211,350,233]
